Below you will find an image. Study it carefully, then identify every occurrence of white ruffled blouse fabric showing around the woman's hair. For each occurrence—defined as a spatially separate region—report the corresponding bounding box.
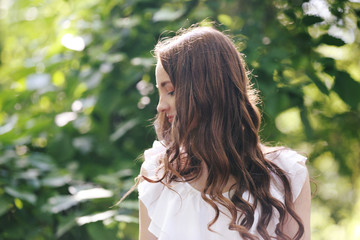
[138,141,307,240]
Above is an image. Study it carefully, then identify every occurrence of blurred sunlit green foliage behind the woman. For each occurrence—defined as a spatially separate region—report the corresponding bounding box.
[0,0,360,240]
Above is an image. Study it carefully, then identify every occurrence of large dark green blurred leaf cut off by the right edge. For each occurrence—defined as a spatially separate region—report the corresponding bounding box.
[333,71,360,109]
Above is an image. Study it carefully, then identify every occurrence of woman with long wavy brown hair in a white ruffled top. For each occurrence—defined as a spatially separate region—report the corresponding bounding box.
[138,27,311,240]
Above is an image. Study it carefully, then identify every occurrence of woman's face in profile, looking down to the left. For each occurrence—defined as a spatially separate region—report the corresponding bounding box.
[155,61,176,123]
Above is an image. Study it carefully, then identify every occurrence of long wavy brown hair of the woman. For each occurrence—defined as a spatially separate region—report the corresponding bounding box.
[150,27,304,239]
